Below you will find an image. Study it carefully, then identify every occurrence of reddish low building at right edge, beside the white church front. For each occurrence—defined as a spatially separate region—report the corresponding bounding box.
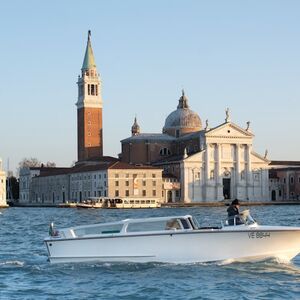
[269,161,300,201]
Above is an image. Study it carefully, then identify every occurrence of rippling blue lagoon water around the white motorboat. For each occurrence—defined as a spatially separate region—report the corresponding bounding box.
[0,205,300,300]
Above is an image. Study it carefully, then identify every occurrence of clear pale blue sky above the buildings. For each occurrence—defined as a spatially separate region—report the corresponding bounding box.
[0,0,300,172]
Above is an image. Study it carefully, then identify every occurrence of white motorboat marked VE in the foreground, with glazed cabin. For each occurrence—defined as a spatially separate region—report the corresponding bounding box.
[45,213,300,263]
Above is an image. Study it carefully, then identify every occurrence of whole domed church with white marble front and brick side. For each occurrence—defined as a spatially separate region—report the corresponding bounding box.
[121,92,270,203]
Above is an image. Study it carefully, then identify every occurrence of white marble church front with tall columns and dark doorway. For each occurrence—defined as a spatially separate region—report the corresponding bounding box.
[180,120,270,203]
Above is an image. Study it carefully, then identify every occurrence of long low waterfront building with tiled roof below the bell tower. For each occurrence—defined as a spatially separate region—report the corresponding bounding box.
[28,157,164,205]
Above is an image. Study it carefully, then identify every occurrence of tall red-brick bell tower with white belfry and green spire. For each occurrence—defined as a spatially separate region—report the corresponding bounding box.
[76,30,103,161]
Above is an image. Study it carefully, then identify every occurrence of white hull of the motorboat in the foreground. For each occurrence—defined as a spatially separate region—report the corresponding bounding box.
[45,226,300,263]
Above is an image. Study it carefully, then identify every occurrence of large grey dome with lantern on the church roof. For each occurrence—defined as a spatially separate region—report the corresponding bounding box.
[163,91,202,137]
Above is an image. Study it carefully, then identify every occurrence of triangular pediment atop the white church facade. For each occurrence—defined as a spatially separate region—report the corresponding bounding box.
[205,122,254,139]
